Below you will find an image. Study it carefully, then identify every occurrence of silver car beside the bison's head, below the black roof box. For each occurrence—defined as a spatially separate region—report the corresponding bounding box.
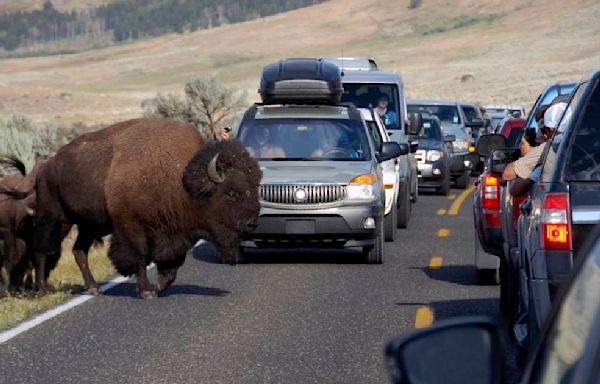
[237,104,409,263]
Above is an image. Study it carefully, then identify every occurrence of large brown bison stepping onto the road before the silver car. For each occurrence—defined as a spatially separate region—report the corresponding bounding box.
[11,119,261,298]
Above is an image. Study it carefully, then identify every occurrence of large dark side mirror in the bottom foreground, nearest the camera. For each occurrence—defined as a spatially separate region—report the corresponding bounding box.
[385,317,504,384]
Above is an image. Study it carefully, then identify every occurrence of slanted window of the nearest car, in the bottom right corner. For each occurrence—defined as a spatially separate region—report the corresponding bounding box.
[536,242,600,384]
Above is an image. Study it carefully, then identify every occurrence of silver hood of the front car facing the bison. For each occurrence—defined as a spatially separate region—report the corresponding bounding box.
[259,161,376,184]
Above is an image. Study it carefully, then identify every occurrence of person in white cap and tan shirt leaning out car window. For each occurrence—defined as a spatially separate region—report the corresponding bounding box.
[502,103,567,180]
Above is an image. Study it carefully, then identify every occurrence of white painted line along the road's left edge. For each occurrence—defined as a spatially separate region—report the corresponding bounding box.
[0,263,154,345]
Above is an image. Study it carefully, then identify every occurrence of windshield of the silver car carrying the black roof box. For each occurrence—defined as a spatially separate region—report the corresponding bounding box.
[238,118,371,161]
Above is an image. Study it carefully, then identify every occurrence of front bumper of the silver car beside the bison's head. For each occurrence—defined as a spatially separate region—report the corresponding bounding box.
[241,204,384,248]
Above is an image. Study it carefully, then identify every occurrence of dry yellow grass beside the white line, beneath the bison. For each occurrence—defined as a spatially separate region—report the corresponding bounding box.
[0,228,115,330]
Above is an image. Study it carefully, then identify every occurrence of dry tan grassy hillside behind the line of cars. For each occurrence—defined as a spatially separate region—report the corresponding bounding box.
[0,0,600,124]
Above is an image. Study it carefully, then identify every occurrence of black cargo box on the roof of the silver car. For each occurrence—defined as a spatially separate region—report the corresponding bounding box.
[258,59,344,104]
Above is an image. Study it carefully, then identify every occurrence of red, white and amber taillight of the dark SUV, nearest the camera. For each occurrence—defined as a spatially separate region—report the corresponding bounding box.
[541,192,572,250]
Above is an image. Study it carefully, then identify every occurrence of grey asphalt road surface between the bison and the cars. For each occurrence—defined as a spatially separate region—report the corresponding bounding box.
[0,185,516,383]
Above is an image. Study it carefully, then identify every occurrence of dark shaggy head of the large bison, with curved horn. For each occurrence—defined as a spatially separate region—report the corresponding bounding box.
[183,140,262,234]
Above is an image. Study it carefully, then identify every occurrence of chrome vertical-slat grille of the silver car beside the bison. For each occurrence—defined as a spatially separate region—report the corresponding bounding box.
[259,184,347,205]
